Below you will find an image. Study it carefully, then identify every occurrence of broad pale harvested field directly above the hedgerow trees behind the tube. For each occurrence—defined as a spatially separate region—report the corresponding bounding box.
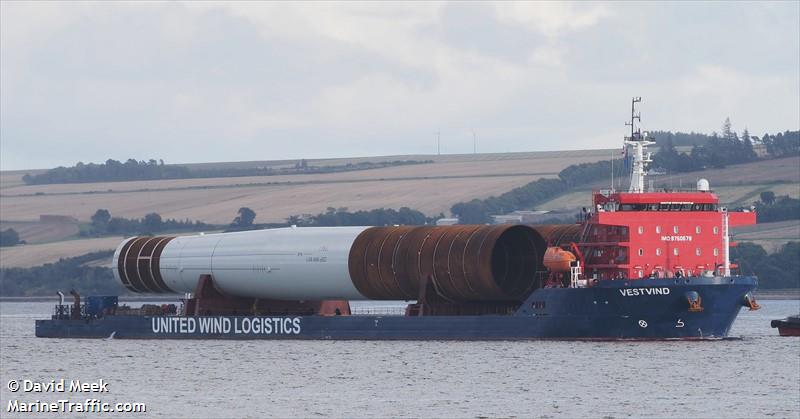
[1,176,544,224]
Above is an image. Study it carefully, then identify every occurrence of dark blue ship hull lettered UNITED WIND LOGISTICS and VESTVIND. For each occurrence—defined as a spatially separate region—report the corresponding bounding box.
[36,277,757,340]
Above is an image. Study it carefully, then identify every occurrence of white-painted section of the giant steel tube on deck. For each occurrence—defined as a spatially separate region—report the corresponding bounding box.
[115,227,368,300]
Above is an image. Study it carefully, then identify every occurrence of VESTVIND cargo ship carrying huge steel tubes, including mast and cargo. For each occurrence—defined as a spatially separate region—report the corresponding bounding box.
[36,98,758,340]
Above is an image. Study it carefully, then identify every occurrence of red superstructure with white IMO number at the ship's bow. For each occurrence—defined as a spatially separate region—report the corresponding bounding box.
[578,189,756,279]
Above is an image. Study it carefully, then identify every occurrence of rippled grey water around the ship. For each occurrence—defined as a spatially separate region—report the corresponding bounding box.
[0,300,800,418]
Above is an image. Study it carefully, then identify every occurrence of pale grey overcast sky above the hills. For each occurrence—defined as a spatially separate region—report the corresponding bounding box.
[0,1,800,170]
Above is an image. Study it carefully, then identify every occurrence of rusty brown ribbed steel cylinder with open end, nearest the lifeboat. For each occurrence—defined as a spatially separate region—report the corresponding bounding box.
[348,225,546,302]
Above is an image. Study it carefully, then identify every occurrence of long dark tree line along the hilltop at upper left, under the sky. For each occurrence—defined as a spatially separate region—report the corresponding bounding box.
[22,159,433,185]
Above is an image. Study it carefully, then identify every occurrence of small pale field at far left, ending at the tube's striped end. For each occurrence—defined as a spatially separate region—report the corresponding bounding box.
[0,237,122,268]
